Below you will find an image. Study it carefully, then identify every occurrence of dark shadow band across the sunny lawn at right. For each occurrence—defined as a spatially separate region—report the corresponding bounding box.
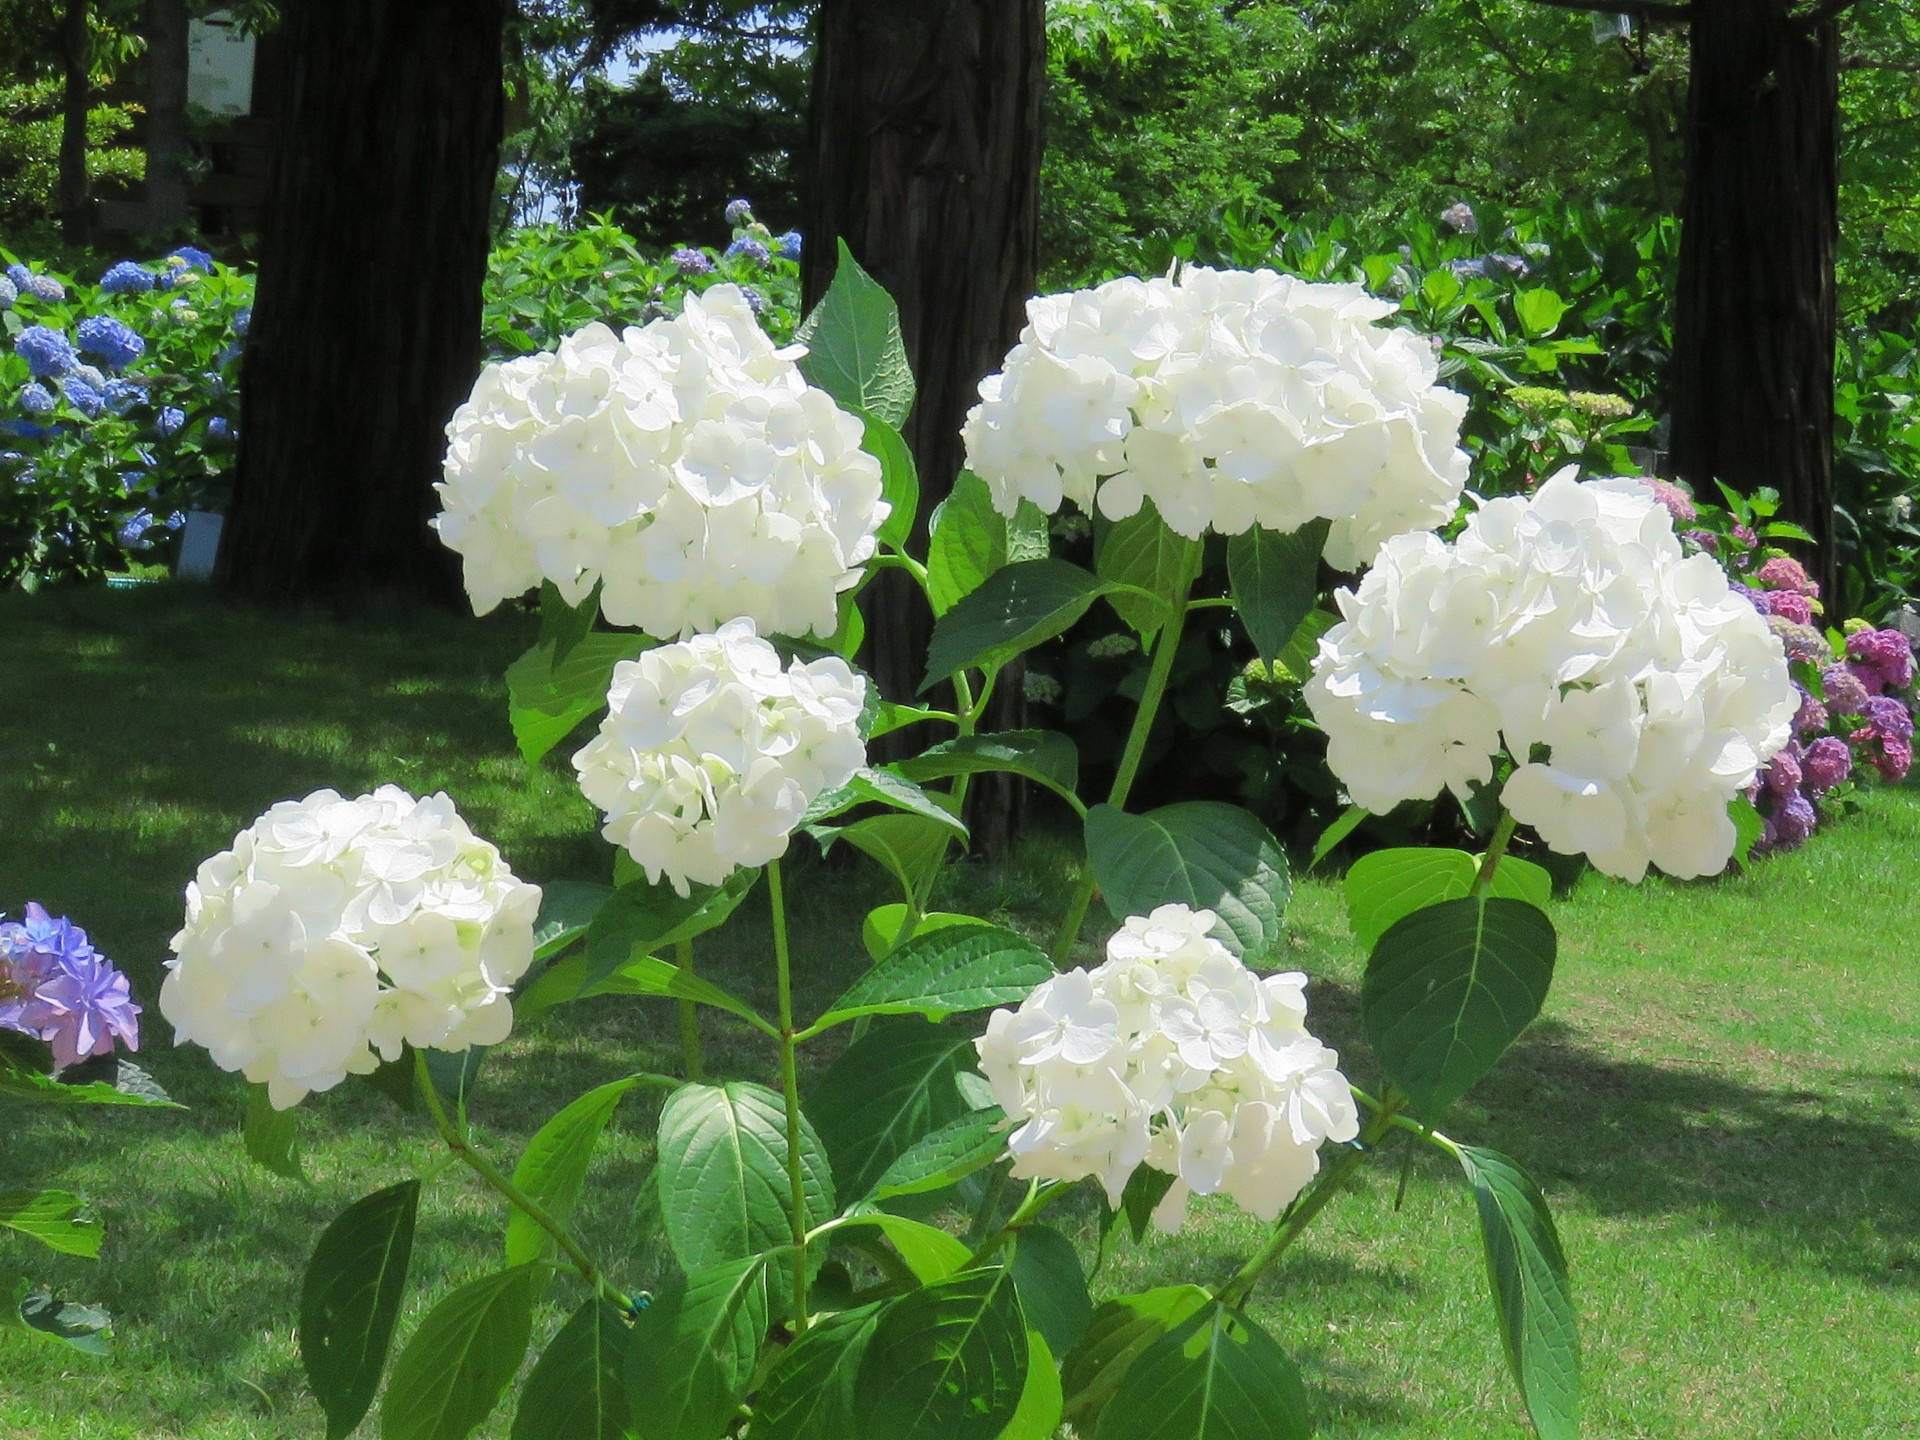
[1313,979,1920,1286]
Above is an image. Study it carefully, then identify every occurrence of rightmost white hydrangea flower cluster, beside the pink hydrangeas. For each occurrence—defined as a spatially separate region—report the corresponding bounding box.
[1306,468,1799,879]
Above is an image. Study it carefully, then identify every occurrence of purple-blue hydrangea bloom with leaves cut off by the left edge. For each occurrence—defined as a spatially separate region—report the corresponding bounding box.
[0,900,171,1354]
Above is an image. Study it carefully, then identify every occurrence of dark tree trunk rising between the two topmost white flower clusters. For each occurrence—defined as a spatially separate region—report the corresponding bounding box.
[803,0,1046,851]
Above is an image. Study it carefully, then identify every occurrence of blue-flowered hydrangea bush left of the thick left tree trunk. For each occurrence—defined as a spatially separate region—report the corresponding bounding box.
[0,246,253,586]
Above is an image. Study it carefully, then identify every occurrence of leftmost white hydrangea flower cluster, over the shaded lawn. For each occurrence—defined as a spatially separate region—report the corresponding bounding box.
[159,785,540,1110]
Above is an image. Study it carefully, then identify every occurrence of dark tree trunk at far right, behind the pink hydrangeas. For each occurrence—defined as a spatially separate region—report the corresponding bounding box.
[1670,0,1839,595]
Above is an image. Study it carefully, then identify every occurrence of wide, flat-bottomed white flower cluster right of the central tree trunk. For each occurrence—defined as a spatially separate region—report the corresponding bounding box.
[964,267,1467,570]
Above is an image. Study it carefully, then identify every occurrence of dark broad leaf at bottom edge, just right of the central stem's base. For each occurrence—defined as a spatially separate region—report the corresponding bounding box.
[854,1267,1027,1440]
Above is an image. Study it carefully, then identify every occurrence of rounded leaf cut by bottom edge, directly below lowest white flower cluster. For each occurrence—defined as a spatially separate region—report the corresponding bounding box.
[1094,1304,1313,1440]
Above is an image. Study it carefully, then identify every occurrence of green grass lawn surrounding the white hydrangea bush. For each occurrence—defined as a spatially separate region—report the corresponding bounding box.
[0,588,1920,1440]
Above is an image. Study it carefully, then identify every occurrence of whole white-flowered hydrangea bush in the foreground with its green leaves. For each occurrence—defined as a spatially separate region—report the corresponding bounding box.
[161,247,1799,1440]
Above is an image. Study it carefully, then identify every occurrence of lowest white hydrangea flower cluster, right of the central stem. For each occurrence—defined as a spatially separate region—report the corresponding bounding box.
[975,904,1359,1233]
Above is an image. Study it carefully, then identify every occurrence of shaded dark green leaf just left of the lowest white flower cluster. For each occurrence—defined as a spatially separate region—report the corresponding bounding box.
[806,1016,975,1196]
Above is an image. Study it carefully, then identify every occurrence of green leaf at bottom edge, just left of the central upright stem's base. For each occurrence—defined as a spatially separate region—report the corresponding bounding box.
[626,1258,768,1440]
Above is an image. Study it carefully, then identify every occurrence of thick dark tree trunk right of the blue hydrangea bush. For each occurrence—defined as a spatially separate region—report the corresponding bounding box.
[219,0,507,603]
